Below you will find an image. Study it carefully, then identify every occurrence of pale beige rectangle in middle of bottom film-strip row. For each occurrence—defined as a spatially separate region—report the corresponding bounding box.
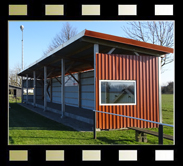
[82,150,101,161]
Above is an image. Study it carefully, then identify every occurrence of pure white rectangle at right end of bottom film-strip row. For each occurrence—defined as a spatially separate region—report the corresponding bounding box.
[155,150,174,161]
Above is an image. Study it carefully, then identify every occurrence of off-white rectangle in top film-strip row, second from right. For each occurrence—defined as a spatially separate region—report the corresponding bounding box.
[118,5,137,15]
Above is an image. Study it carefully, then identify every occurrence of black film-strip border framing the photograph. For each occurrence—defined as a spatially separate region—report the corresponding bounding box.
[0,0,180,165]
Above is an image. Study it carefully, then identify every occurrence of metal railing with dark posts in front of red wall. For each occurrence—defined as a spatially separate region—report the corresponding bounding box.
[93,110,174,144]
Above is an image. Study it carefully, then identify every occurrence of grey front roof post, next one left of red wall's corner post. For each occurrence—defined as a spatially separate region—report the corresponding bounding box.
[61,59,65,118]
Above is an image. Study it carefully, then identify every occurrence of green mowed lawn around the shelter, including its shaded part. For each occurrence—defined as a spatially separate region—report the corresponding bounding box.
[9,94,173,145]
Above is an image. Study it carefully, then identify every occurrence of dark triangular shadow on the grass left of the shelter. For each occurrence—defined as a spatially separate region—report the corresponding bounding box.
[9,103,76,131]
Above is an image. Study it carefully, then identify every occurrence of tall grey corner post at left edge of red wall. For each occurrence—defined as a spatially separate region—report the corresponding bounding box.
[93,44,99,139]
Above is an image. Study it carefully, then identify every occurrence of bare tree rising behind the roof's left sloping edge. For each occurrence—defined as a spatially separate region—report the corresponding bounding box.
[43,22,77,55]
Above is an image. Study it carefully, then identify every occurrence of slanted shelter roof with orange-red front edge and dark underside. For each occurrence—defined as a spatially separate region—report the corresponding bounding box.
[18,30,173,78]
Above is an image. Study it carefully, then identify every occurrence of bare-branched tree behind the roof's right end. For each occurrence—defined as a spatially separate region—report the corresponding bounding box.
[122,21,174,66]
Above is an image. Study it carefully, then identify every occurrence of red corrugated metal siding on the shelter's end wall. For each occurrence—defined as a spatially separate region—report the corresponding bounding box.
[96,53,159,129]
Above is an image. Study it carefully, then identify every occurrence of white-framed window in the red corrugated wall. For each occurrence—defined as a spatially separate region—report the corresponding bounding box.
[99,80,136,105]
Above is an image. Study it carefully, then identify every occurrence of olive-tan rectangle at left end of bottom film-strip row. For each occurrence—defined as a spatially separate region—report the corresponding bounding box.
[9,150,28,161]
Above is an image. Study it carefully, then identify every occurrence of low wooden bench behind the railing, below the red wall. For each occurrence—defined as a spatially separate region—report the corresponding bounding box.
[128,127,173,142]
